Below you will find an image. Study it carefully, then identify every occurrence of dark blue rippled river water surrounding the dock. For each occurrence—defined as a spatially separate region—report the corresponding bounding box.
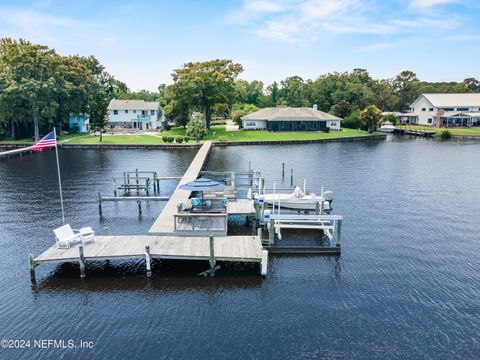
[0,139,480,359]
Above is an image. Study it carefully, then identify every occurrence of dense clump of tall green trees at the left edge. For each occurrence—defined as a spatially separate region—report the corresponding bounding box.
[0,38,128,140]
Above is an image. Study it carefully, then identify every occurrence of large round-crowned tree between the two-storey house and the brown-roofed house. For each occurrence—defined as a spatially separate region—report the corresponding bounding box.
[172,59,243,127]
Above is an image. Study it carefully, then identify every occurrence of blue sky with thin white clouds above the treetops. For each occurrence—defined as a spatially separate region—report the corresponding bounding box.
[0,0,480,90]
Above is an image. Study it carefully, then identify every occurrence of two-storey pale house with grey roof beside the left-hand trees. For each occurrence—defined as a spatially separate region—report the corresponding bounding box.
[108,99,165,130]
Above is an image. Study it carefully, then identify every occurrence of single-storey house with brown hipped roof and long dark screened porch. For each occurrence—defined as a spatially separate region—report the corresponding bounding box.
[241,105,342,131]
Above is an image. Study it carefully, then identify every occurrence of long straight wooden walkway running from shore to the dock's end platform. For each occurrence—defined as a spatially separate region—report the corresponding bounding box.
[148,141,212,235]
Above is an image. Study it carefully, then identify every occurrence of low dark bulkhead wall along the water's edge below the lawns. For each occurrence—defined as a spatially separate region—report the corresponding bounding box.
[0,134,387,155]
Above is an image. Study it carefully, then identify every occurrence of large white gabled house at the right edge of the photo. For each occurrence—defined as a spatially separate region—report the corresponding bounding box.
[397,93,480,126]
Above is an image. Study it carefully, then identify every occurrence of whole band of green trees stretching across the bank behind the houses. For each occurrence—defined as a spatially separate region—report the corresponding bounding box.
[0,38,480,139]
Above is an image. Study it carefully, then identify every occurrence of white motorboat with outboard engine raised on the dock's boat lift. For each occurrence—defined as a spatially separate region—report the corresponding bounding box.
[255,187,333,211]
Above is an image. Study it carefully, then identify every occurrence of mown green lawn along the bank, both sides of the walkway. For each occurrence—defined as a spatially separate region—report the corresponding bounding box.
[0,126,378,145]
